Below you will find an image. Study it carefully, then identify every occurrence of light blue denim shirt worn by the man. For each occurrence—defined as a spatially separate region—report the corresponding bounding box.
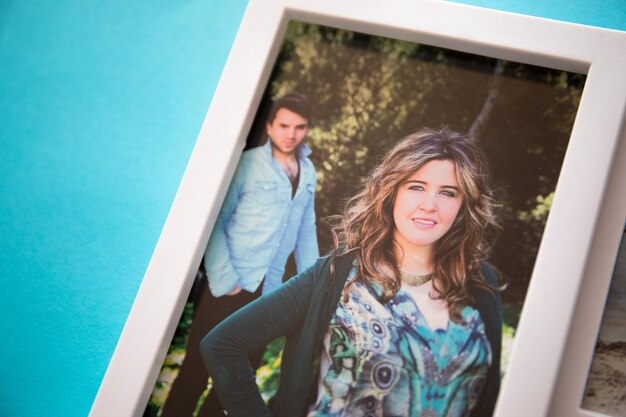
[204,139,319,297]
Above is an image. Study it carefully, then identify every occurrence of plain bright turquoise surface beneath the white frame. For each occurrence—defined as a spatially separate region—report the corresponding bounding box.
[0,0,626,417]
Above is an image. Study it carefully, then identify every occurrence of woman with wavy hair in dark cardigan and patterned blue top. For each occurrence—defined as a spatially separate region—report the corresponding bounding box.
[201,129,502,417]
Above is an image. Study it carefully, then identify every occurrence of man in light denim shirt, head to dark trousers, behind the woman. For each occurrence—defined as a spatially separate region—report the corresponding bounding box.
[162,93,319,417]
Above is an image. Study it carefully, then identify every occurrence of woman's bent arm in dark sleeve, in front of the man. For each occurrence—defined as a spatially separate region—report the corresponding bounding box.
[200,258,327,417]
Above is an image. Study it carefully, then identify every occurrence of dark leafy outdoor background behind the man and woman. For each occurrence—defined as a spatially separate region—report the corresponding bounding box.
[146,22,585,416]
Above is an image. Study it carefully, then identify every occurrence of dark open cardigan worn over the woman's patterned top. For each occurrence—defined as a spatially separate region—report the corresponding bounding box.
[200,256,502,417]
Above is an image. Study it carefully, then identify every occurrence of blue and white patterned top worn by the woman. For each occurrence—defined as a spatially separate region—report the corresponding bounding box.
[308,274,492,417]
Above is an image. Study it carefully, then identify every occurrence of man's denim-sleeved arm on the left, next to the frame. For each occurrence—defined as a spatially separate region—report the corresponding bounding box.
[204,169,243,297]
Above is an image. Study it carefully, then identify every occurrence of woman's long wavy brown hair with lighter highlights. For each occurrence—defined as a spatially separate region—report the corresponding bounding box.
[332,128,499,321]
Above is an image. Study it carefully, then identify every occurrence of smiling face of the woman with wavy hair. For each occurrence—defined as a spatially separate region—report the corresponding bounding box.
[393,160,463,254]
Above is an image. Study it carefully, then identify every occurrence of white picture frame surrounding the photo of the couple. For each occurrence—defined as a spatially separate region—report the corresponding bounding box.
[90,0,626,417]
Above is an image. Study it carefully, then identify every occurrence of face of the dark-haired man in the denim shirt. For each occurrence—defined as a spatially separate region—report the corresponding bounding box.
[266,108,309,155]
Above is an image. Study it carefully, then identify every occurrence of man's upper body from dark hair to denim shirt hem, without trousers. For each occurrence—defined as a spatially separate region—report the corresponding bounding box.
[205,94,319,298]
